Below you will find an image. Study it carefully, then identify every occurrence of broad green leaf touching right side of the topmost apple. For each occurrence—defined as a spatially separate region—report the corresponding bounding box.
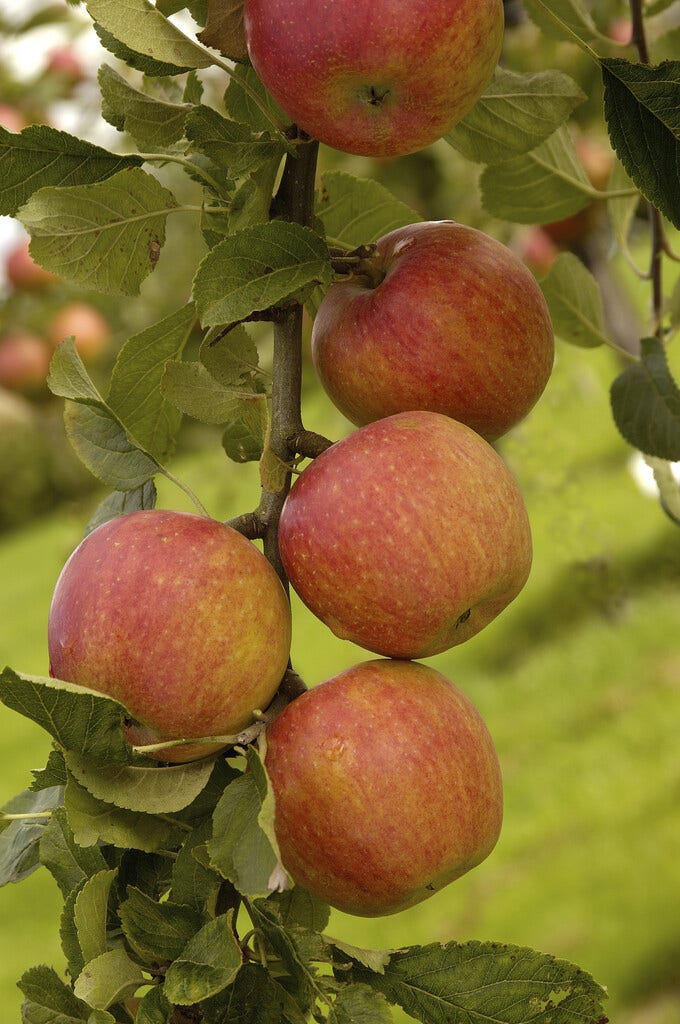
[444,67,586,164]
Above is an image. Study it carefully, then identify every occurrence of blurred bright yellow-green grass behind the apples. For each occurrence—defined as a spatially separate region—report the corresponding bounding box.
[0,331,680,1024]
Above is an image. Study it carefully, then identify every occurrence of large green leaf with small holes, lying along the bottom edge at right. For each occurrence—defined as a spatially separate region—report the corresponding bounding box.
[352,942,606,1024]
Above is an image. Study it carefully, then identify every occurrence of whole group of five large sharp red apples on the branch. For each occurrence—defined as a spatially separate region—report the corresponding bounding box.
[49,0,554,915]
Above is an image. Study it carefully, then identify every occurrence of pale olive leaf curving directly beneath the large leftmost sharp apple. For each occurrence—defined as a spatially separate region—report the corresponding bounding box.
[67,754,213,814]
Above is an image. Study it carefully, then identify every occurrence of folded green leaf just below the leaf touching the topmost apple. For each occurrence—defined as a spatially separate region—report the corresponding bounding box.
[479,127,595,224]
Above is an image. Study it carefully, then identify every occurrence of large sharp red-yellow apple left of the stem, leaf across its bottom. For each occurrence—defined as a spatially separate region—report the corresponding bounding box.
[48,509,291,762]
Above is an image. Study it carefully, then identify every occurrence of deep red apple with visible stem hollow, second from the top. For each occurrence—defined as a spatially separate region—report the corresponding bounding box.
[311,220,555,440]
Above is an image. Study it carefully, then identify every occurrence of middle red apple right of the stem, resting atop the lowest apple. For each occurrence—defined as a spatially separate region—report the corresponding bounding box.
[279,412,532,658]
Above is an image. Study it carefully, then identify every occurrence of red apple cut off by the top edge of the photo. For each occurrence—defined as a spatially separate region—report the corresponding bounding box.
[244,0,504,157]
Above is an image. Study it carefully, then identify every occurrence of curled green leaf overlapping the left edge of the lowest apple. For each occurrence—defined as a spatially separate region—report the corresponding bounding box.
[208,771,277,896]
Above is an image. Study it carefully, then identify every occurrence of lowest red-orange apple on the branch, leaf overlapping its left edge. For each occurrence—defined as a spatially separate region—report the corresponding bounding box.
[265,660,503,916]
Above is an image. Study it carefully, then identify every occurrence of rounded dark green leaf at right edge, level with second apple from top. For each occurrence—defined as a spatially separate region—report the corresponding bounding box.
[610,338,680,462]
